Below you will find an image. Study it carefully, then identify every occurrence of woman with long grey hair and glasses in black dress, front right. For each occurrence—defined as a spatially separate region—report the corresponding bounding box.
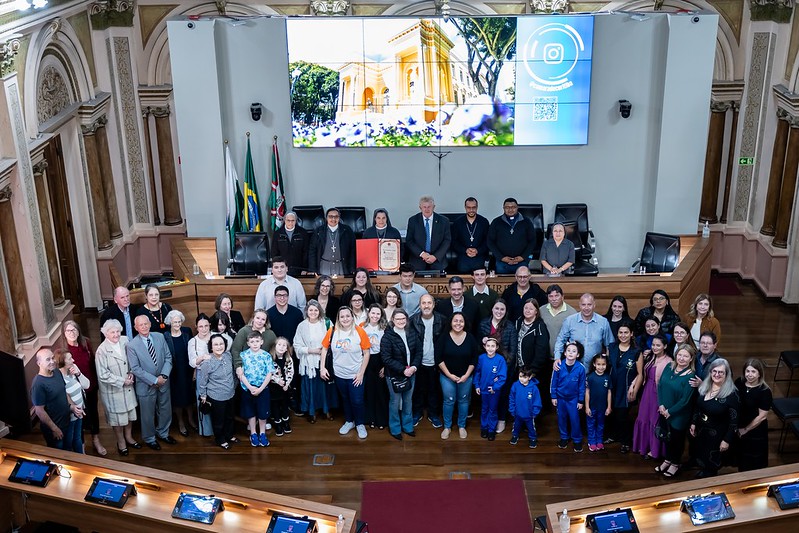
[689,358,741,478]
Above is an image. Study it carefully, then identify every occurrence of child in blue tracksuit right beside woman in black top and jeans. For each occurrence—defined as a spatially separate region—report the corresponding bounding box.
[474,337,508,440]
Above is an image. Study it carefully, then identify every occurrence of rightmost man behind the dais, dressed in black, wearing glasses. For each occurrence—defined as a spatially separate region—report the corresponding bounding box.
[488,198,536,274]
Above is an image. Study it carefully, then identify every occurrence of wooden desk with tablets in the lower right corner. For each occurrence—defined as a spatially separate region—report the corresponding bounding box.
[547,463,799,533]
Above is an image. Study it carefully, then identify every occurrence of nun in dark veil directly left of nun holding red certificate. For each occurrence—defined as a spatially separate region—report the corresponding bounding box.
[308,207,355,276]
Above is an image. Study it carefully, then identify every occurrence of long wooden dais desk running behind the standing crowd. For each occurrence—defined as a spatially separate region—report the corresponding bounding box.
[164,235,712,325]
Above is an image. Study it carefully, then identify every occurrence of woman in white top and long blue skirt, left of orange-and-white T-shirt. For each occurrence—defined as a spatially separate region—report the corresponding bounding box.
[294,300,338,424]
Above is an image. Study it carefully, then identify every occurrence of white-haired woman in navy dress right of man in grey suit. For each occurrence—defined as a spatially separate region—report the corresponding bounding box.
[164,309,197,437]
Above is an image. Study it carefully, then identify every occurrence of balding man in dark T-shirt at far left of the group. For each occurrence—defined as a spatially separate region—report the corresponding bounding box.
[31,348,83,450]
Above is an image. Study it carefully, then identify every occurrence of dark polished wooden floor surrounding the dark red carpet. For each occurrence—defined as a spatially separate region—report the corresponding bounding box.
[10,276,799,517]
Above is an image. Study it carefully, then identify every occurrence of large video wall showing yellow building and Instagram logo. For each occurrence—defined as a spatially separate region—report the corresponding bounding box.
[286,15,594,148]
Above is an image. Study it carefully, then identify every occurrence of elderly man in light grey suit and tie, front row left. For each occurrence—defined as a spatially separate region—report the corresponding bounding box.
[127,315,177,450]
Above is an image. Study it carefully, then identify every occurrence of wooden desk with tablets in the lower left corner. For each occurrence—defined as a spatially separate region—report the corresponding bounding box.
[0,439,355,533]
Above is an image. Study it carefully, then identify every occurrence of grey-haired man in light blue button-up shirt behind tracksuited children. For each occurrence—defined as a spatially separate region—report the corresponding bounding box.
[553,293,613,370]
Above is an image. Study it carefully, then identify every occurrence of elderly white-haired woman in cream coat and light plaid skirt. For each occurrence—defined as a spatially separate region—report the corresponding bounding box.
[94,318,141,456]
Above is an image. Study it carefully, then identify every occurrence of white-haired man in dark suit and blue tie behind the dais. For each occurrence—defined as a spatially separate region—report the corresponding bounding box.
[405,196,452,271]
